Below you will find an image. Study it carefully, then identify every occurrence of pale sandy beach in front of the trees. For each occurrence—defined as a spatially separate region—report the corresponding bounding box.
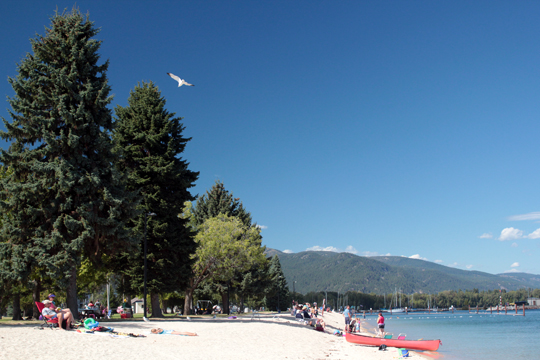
[0,313,428,360]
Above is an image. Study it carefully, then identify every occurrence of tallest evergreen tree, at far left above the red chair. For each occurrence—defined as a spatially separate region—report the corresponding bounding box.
[0,9,136,315]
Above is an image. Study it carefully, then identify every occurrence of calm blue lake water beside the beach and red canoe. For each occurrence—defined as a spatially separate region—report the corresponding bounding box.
[357,310,540,360]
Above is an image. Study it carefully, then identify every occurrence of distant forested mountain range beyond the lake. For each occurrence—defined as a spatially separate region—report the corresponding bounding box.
[266,249,540,294]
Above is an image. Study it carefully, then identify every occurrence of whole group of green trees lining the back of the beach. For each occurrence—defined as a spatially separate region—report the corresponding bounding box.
[0,8,287,319]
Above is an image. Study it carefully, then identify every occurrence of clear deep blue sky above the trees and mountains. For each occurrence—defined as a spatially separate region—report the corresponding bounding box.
[0,0,540,274]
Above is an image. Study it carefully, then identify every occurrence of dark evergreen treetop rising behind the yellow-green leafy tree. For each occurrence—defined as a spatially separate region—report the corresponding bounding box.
[193,181,253,226]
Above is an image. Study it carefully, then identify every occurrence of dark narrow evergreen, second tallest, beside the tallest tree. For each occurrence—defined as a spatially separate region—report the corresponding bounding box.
[114,82,199,317]
